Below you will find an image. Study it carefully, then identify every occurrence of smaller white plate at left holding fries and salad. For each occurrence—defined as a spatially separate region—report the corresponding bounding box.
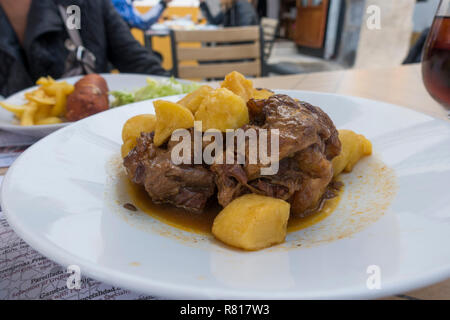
[0,73,188,138]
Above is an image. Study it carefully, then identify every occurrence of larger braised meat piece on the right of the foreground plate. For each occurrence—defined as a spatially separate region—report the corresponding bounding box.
[211,95,341,216]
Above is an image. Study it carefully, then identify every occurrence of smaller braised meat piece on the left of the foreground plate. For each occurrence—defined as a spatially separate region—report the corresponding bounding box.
[124,133,215,212]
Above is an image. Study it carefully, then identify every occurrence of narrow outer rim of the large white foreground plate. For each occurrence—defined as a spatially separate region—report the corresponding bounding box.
[0,89,450,299]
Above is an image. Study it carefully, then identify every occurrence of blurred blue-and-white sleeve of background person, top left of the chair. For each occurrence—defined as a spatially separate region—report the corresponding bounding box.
[112,0,172,31]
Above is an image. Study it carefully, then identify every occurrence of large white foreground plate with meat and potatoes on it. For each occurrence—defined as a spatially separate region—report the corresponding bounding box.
[1,91,450,299]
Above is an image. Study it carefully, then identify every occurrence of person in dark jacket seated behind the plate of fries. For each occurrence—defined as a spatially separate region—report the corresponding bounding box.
[0,0,168,96]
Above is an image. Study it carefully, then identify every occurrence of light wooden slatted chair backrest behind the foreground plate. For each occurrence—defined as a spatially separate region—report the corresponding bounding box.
[171,26,264,79]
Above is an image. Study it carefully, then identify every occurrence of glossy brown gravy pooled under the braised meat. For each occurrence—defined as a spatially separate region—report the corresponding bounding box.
[126,179,344,235]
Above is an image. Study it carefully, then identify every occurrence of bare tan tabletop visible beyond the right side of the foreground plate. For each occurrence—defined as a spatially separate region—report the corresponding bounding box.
[253,64,450,300]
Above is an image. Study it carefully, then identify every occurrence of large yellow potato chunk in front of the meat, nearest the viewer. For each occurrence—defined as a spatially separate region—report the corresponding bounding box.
[212,194,291,250]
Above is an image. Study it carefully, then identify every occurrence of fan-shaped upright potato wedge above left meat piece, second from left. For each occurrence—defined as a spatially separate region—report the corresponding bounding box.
[153,100,194,147]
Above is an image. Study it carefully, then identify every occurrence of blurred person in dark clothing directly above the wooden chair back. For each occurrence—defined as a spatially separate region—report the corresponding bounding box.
[200,0,259,27]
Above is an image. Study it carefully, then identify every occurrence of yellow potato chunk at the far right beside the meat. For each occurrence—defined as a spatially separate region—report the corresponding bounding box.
[332,130,372,177]
